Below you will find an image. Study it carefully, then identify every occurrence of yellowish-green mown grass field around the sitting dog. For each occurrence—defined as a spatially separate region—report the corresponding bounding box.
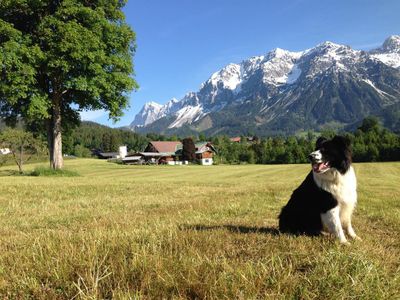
[0,159,400,299]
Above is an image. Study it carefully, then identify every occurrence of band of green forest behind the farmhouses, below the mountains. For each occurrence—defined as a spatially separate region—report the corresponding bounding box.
[58,117,400,164]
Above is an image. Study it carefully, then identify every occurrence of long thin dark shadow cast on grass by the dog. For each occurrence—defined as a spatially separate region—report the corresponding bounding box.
[180,224,281,235]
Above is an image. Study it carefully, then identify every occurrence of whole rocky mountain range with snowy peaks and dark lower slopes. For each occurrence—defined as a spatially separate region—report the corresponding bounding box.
[129,35,400,136]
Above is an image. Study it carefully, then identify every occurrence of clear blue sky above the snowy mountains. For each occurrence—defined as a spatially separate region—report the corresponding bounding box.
[82,0,400,127]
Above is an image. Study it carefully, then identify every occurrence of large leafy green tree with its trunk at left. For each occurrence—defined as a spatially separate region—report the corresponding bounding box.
[0,0,137,169]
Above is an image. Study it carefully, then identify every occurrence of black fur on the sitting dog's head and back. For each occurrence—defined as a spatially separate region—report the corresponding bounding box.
[279,136,351,235]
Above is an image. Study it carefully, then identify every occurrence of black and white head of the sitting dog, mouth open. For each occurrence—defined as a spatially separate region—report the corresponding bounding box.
[309,136,351,174]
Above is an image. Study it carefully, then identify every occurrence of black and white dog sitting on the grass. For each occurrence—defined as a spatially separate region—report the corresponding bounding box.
[279,136,359,243]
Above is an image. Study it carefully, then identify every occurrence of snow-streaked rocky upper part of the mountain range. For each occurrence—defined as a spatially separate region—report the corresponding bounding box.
[131,35,400,128]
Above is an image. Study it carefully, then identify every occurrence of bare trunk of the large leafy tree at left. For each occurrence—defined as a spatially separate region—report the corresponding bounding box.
[47,94,64,170]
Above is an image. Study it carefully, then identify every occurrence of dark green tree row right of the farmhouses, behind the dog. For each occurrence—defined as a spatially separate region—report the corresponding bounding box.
[212,118,400,164]
